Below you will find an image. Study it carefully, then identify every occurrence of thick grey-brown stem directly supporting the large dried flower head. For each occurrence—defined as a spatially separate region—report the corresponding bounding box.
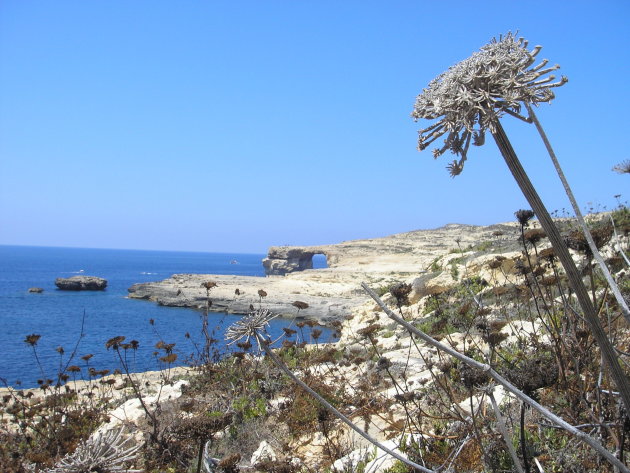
[492,120,630,415]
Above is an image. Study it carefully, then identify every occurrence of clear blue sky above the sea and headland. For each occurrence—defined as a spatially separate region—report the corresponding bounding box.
[0,0,630,253]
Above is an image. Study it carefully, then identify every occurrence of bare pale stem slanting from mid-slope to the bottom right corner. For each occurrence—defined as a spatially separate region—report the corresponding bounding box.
[361,283,630,473]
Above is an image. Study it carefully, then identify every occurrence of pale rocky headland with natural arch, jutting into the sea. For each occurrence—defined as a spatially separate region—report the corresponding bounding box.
[129,223,518,324]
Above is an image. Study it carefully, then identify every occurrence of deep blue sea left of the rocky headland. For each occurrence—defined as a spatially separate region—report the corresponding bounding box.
[0,245,334,388]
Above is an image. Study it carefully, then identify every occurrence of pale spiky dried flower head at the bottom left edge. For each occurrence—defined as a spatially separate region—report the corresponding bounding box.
[46,428,142,473]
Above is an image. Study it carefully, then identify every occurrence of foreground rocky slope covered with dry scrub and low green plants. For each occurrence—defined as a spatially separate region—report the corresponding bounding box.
[0,206,630,473]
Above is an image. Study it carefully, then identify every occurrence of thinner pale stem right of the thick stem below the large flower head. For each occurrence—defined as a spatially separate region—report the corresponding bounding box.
[525,103,630,323]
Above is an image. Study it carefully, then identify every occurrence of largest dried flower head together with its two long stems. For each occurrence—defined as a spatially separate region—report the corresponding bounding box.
[412,33,630,412]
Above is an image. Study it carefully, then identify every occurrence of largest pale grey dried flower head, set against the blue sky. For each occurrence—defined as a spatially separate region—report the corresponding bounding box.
[411,33,567,177]
